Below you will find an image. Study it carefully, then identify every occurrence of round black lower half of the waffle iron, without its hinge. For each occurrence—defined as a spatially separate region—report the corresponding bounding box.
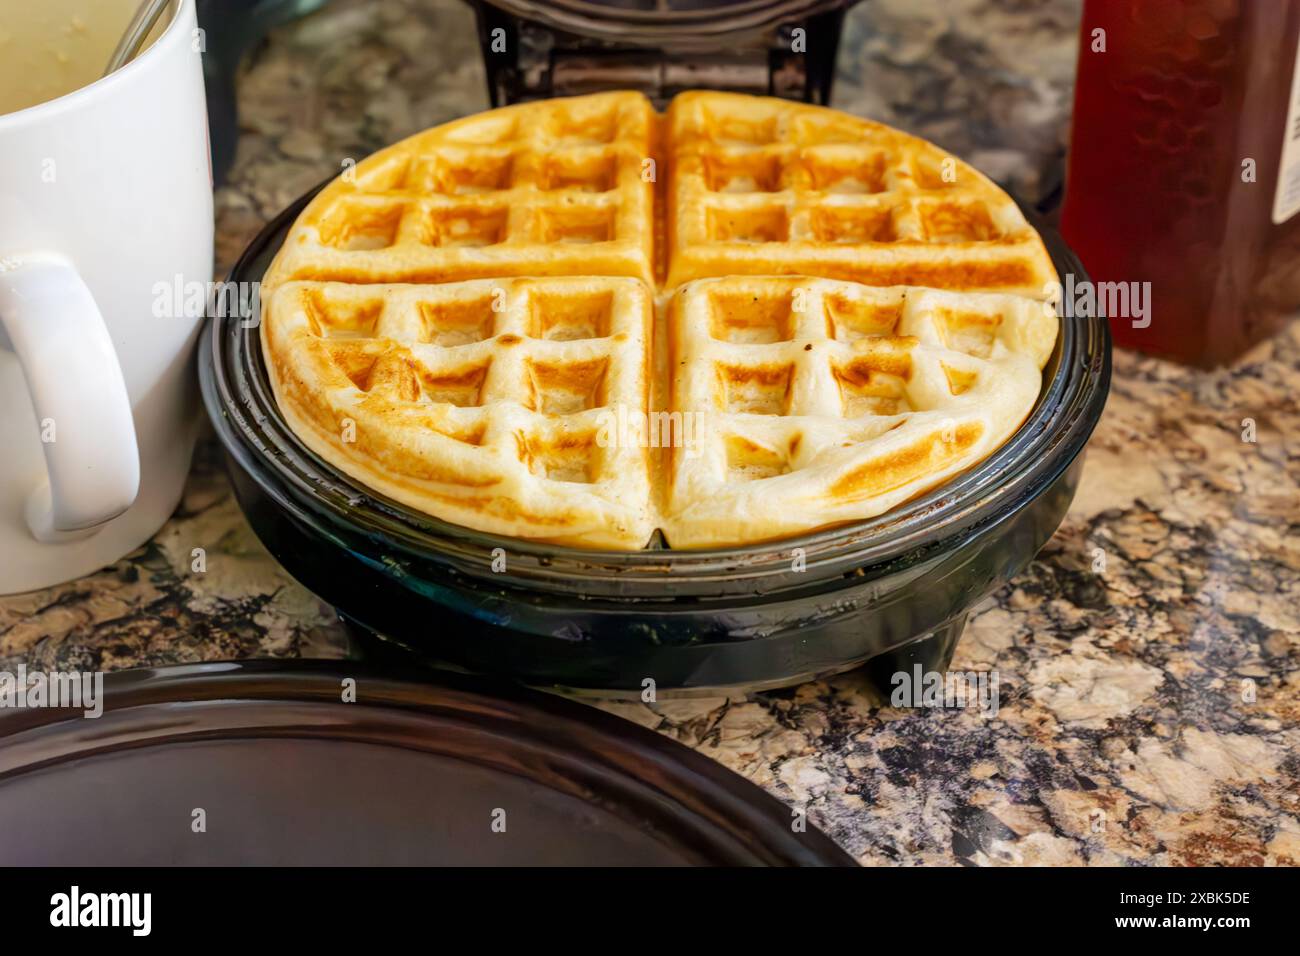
[199,183,1110,693]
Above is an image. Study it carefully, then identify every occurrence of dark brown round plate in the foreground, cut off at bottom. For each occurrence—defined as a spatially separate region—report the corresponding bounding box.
[0,661,853,866]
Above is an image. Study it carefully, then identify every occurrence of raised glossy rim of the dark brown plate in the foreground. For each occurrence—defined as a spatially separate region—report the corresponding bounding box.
[0,659,857,866]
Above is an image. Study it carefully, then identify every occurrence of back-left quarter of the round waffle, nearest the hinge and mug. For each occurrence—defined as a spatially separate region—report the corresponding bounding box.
[265,92,657,295]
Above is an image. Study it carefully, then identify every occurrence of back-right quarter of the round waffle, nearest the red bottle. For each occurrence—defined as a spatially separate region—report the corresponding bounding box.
[668,92,1056,295]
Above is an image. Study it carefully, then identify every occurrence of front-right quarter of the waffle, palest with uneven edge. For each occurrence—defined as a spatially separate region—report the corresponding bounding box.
[663,276,1057,548]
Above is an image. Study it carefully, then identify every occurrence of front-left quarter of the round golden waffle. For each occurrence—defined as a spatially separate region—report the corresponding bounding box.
[263,277,654,548]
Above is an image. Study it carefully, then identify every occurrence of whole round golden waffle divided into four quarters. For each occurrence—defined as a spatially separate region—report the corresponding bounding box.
[261,92,1057,549]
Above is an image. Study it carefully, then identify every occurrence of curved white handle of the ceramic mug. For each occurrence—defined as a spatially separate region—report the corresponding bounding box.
[0,254,140,544]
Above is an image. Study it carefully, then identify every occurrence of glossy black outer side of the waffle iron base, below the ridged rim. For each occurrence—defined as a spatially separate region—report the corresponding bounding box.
[226,455,1083,697]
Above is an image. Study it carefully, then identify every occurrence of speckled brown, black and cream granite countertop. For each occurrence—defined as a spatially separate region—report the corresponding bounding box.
[0,0,1300,865]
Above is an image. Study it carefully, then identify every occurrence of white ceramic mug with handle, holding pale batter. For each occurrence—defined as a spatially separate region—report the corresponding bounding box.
[0,0,212,594]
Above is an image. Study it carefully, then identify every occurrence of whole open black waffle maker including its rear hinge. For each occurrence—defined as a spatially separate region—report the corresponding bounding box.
[199,0,1110,695]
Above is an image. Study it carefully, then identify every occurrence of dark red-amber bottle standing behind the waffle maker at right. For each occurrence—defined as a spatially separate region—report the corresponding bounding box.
[1061,0,1300,365]
